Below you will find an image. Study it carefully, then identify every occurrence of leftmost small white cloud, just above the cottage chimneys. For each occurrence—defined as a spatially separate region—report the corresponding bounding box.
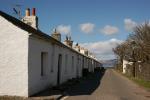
[57,25,71,34]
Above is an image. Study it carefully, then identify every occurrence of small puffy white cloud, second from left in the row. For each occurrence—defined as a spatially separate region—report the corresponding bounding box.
[80,23,95,33]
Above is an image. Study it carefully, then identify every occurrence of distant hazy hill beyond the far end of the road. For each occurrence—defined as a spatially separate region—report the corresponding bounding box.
[100,59,117,67]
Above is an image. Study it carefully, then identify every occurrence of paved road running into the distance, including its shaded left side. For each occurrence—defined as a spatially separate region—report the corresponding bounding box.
[65,69,150,100]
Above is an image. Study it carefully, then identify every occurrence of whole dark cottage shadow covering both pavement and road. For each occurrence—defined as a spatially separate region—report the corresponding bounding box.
[31,69,105,99]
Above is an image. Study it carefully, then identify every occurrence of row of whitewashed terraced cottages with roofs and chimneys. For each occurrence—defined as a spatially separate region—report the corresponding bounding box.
[0,8,100,97]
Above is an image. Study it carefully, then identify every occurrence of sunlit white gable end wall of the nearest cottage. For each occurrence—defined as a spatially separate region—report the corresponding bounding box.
[0,16,28,96]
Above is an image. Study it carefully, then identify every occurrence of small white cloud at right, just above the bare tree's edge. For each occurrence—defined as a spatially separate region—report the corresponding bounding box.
[124,18,137,32]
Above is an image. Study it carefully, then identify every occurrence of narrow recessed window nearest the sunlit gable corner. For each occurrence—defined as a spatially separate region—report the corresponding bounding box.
[41,52,48,76]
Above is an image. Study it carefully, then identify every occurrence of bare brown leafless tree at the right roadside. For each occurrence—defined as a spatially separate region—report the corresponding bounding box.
[113,22,150,70]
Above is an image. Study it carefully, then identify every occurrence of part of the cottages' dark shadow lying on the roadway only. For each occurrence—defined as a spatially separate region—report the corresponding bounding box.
[67,69,105,96]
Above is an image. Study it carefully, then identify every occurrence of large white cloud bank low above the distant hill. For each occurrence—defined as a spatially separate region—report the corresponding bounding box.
[81,39,123,60]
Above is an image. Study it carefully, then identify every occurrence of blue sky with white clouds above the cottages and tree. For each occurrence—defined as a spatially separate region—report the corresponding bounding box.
[0,0,150,59]
